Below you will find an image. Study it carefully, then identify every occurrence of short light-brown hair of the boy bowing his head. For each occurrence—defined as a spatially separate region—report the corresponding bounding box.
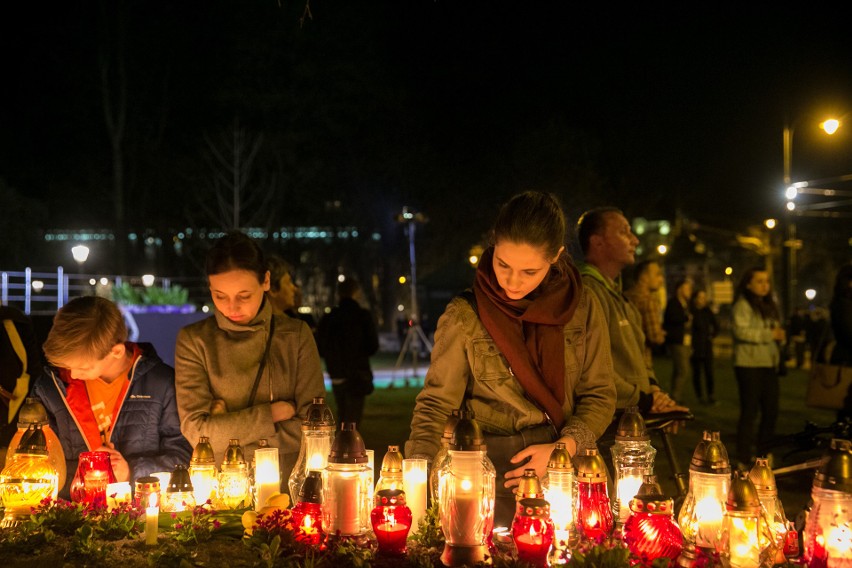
[43,296,127,365]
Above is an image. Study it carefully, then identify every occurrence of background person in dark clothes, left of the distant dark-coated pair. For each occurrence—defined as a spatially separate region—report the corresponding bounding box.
[663,278,692,401]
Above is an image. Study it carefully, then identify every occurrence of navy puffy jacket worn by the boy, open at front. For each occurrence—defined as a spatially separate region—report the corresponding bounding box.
[33,343,192,499]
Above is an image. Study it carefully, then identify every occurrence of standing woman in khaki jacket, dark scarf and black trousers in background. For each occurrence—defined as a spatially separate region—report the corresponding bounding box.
[731,267,786,468]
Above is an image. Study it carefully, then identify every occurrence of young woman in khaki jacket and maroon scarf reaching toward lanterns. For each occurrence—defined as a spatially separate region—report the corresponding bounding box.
[405,192,615,526]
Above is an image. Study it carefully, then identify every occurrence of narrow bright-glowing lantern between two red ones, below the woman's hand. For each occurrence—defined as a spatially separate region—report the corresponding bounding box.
[541,442,574,564]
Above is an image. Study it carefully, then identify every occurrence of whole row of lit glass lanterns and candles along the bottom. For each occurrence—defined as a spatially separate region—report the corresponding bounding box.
[0,398,852,568]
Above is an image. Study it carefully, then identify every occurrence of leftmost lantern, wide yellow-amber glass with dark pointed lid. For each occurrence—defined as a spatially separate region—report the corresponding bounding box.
[0,425,59,528]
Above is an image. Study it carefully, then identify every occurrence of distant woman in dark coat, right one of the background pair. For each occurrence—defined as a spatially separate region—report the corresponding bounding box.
[689,290,719,406]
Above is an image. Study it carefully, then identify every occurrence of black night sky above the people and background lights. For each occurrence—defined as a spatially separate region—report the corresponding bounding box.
[0,0,852,272]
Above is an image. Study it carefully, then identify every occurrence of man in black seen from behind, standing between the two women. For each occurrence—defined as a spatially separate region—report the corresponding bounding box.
[317,278,379,426]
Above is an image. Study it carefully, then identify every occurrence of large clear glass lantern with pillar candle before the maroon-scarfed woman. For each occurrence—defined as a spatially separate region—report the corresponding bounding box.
[438,410,497,566]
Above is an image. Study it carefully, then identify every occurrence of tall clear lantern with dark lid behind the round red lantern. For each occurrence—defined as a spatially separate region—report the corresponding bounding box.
[611,406,657,526]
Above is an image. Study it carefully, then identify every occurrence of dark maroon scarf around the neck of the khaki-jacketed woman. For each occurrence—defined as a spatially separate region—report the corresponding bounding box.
[474,246,582,429]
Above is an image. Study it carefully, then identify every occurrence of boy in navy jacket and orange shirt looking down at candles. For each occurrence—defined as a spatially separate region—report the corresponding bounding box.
[33,296,192,499]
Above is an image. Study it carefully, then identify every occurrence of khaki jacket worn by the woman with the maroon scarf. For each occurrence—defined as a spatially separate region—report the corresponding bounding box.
[405,288,615,460]
